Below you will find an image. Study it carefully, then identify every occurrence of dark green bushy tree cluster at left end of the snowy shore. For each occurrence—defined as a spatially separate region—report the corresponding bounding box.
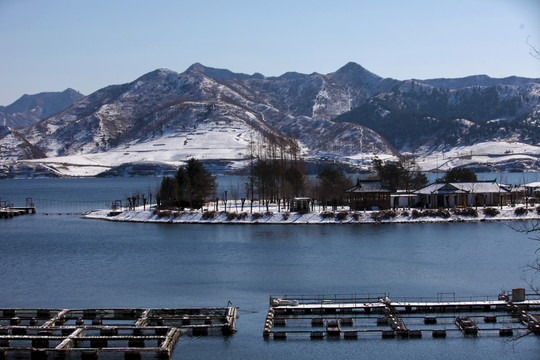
[158,158,217,209]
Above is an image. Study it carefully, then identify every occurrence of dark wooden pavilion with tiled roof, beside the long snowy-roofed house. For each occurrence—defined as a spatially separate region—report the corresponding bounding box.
[345,180,394,210]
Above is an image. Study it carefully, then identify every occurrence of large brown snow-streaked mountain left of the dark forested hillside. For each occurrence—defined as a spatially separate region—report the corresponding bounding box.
[3,64,397,179]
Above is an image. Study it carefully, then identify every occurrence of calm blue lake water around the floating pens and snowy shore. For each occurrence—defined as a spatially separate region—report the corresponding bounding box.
[0,178,540,359]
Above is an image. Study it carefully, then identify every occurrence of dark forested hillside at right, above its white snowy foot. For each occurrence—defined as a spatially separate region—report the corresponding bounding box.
[335,79,540,153]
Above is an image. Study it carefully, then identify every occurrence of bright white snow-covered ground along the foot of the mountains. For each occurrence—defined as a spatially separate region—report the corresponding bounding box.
[6,136,540,177]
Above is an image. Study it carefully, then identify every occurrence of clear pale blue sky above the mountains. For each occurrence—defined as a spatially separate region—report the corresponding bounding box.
[0,0,540,105]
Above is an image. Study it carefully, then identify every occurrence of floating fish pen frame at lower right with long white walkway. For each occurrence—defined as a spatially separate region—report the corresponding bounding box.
[263,289,540,340]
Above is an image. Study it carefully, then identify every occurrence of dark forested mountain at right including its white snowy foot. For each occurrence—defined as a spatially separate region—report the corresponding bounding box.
[335,75,540,171]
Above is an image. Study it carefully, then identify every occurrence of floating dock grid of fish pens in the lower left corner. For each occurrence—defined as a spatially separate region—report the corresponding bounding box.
[0,307,237,360]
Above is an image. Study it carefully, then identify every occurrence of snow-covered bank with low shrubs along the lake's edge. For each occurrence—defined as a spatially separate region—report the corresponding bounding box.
[84,207,540,224]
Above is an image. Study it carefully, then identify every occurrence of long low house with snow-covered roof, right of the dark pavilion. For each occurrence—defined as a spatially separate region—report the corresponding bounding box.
[415,180,510,209]
